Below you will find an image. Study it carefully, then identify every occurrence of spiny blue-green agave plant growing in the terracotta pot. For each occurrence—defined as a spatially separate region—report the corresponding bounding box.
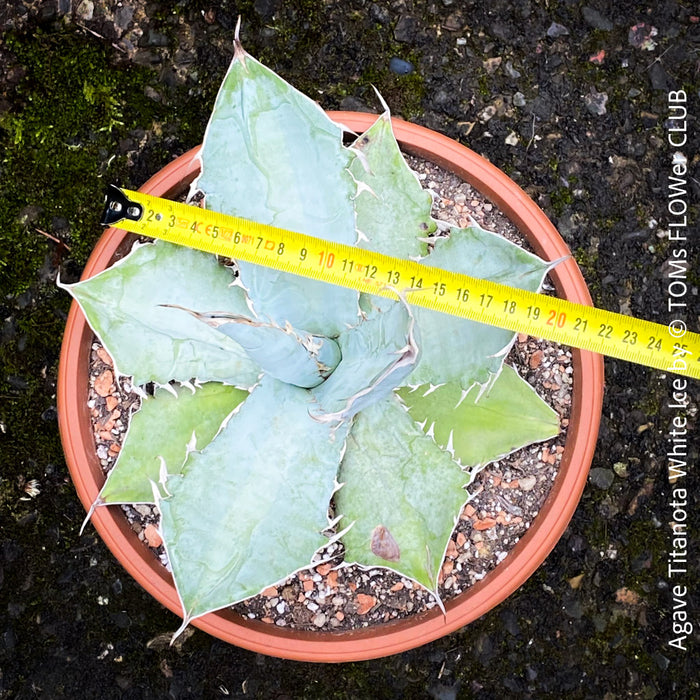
[65,41,558,640]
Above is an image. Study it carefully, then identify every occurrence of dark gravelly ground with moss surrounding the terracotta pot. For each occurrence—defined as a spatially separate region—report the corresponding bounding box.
[0,0,700,700]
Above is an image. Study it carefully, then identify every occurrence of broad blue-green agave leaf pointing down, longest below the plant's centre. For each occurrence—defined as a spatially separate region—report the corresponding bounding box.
[158,377,345,627]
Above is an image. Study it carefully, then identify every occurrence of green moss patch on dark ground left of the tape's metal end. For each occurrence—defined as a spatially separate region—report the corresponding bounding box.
[0,31,170,294]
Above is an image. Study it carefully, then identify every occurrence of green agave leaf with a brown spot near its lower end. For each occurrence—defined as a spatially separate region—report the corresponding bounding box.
[336,396,470,593]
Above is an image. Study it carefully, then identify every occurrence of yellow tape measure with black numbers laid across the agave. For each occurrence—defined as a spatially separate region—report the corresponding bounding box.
[102,186,700,379]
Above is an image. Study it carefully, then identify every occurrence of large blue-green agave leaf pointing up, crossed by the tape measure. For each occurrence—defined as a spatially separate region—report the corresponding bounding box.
[195,45,358,336]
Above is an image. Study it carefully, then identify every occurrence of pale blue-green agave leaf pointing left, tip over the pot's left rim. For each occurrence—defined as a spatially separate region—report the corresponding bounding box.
[63,241,260,387]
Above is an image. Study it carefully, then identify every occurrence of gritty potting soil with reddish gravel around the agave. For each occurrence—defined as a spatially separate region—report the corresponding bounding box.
[83,157,573,631]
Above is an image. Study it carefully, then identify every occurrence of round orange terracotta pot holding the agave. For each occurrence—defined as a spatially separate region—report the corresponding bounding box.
[58,112,603,662]
